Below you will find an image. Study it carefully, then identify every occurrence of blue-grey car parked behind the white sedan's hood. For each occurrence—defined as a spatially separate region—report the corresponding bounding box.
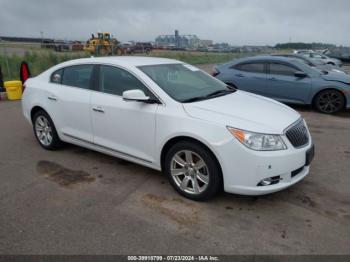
[213,56,350,114]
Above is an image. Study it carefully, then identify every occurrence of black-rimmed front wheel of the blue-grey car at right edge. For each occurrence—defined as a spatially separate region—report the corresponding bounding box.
[314,89,345,114]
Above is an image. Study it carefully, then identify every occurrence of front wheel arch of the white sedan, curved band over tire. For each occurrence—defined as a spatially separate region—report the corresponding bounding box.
[160,136,224,189]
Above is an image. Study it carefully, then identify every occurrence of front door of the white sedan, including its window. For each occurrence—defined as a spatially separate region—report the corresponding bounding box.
[90,65,158,162]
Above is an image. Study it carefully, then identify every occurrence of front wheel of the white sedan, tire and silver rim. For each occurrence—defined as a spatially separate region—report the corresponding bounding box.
[163,141,222,201]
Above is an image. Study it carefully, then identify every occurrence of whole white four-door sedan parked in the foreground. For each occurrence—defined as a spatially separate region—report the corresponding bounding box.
[22,57,314,200]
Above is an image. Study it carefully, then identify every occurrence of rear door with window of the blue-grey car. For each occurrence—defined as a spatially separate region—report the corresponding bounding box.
[232,61,267,94]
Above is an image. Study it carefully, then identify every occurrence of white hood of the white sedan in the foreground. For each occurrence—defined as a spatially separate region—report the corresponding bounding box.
[183,91,300,134]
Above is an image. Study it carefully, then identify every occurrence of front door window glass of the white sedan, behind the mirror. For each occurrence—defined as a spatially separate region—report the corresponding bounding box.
[99,65,152,96]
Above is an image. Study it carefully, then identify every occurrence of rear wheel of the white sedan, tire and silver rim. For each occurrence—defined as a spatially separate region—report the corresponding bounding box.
[33,110,62,150]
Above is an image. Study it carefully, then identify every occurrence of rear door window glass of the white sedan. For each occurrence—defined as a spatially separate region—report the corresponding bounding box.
[62,65,93,89]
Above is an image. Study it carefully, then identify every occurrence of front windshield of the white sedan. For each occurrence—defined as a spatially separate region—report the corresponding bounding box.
[138,64,235,103]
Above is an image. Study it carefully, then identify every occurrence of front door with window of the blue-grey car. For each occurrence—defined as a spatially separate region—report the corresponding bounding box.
[264,61,311,103]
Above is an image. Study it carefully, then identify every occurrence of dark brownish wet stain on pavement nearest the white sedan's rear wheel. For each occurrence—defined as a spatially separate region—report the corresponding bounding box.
[37,161,95,187]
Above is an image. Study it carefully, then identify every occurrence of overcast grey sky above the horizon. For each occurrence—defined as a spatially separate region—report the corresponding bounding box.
[0,0,350,46]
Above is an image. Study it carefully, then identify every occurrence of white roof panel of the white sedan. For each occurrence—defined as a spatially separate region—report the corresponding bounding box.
[62,56,182,67]
